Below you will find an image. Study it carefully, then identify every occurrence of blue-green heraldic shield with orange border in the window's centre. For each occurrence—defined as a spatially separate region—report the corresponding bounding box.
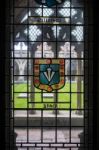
[33,59,65,92]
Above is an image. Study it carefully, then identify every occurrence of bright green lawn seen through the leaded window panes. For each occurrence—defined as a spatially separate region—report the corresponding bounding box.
[12,83,83,109]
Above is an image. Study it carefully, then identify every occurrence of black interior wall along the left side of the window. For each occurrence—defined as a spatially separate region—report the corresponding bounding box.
[0,0,11,150]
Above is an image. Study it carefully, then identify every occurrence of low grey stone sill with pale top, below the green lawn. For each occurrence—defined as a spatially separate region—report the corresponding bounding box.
[14,111,84,127]
